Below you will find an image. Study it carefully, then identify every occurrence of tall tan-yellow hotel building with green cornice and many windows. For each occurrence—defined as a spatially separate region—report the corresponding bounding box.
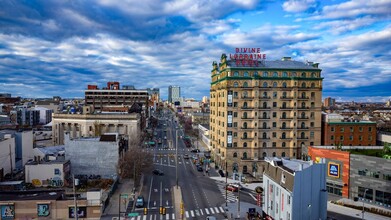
[210,54,323,173]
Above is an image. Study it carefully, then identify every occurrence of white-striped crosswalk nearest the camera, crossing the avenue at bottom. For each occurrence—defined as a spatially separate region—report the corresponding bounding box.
[127,206,225,220]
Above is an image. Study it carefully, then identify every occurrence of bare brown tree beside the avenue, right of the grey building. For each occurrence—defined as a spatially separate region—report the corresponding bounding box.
[118,133,153,187]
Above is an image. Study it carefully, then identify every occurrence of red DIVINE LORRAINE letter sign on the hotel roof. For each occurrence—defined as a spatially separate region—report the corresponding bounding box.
[229,47,266,66]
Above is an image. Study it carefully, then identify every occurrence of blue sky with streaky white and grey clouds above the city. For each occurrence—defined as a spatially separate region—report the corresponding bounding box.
[0,0,391,101]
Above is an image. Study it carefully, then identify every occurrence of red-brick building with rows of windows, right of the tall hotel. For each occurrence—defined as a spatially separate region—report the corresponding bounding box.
[321,114,376,146]
